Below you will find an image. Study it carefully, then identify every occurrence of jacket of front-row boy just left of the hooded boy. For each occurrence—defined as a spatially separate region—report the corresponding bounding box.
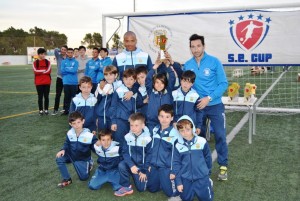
[150,125,179,173]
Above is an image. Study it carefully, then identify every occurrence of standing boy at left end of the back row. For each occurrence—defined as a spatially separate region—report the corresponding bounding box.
[70,76,97,133]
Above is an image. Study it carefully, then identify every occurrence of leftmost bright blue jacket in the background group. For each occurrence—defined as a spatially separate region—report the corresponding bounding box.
[60,58,79,85]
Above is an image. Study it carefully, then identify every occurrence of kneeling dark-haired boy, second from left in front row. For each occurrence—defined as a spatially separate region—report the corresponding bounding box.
[88,129,122,191]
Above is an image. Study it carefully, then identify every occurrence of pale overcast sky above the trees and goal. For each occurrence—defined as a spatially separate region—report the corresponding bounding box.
[0,0,300,47]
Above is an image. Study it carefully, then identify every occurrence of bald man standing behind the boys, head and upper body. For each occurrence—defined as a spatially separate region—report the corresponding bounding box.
[112,31,152,80]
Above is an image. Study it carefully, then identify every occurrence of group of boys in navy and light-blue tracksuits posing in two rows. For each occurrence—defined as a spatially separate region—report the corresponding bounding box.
[52,33,227,200]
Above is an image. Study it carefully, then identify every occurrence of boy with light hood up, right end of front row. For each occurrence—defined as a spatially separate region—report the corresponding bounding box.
[173,115,214,201]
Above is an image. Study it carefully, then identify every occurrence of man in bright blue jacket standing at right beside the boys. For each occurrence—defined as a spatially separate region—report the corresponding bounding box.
[184,34,228,180]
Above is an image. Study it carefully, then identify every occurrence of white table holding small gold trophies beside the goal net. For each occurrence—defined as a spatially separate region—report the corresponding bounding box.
[222,96,257,144]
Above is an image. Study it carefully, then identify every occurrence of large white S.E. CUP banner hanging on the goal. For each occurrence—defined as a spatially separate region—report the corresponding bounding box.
[128,10,300,66]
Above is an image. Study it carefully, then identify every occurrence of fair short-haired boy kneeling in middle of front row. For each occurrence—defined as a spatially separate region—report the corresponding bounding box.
[115,112,151,196]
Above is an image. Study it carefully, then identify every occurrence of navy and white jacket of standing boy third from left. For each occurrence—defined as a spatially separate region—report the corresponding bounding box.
[111,84,143,124]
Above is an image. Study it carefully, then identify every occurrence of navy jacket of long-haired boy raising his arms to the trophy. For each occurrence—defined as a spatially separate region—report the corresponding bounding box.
[146,68,175,125]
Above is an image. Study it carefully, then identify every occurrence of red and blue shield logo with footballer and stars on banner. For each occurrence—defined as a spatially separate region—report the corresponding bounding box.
[228,13,272,51]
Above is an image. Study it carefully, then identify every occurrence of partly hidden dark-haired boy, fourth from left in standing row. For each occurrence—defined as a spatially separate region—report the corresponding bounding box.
[135,66,149,117]
